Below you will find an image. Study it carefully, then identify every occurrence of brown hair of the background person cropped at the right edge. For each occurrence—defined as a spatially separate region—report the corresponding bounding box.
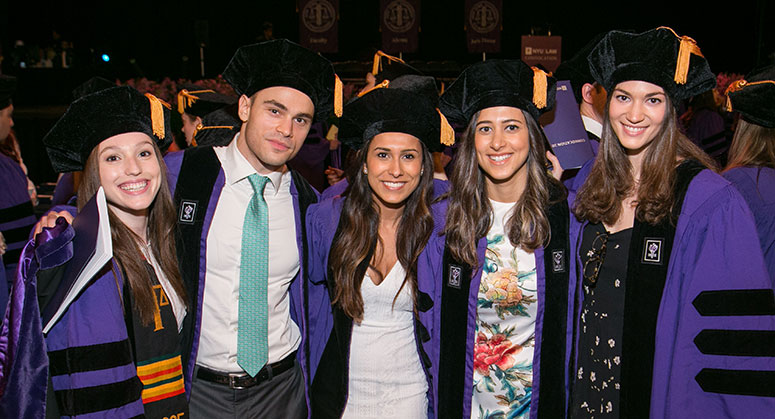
[724,119,775,170]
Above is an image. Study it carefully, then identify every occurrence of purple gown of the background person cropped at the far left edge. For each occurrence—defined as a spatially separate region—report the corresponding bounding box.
[0,153,37,310]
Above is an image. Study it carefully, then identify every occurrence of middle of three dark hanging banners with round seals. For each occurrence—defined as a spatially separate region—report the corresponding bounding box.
[379,0,420,54]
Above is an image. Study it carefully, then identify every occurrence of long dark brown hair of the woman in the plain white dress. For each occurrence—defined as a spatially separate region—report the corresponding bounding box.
[328,140,433,322]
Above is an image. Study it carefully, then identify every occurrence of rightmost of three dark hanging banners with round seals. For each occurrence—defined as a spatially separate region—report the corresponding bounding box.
[465,0,503,52]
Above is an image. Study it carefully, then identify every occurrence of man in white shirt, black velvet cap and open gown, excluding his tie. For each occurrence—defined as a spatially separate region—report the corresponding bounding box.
[166,40,336,418]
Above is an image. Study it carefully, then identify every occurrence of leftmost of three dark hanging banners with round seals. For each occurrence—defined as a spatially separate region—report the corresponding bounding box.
[299,0,339,52]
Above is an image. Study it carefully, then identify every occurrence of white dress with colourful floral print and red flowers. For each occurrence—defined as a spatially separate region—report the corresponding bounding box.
[471,200,538,419]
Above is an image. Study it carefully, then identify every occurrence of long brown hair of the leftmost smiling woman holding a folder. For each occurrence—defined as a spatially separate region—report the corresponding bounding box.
[78,141,186,325]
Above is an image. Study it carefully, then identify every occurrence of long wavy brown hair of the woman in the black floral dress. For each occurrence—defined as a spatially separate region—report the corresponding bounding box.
[573,91,717,224]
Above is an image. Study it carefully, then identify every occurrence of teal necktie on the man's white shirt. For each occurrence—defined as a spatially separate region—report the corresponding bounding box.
[237,173,269,377]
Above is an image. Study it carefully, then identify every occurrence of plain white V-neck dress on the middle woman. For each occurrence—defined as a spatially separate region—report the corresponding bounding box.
[342,262,428,419]
